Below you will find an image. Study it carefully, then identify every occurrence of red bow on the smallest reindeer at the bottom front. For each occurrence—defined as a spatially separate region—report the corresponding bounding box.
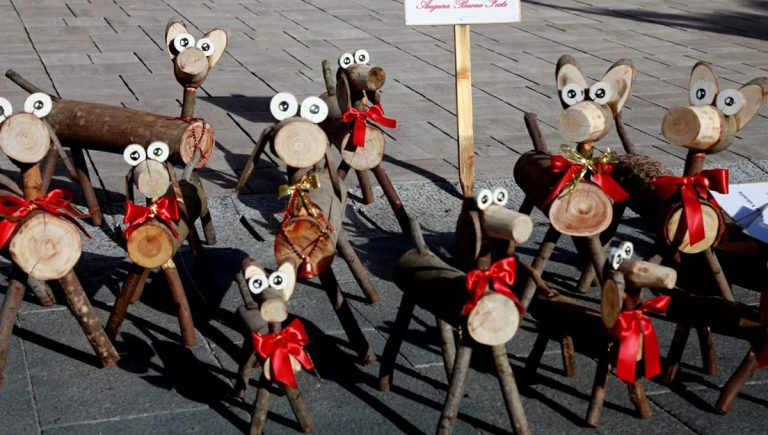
[251,319,315,388]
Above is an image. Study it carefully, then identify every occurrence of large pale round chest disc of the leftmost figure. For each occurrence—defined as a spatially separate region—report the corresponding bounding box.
[8,211,83,281]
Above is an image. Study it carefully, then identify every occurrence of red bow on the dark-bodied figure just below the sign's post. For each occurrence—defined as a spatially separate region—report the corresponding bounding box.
[461,257,525,316]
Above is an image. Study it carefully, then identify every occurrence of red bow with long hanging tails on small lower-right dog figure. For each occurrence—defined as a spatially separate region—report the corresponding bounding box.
[610,296,672,383]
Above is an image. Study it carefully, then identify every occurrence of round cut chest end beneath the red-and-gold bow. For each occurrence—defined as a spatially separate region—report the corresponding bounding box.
[549,182,613,236]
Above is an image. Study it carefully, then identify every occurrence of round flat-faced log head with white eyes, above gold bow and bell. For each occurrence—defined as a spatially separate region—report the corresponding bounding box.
[264,92,330,168]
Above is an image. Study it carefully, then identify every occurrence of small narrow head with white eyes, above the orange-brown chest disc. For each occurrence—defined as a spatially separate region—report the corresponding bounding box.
[123,141,171,199]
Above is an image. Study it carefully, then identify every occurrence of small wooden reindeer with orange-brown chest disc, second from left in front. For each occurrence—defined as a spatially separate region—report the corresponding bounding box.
[107,141,204,346]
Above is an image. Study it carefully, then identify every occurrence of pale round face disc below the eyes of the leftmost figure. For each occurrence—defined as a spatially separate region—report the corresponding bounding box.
[0,113,51,163]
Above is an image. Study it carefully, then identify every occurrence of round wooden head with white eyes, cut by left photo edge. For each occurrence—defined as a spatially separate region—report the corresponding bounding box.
[0,92,53,164]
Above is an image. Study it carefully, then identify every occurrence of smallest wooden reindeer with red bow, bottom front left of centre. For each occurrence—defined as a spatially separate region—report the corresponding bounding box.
[230,257,314,435]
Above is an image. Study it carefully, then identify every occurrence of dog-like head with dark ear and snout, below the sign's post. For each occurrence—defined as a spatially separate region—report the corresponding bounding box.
[456,187,533,265]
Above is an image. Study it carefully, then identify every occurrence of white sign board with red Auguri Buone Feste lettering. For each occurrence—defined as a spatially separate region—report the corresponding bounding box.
[405,0,520,26]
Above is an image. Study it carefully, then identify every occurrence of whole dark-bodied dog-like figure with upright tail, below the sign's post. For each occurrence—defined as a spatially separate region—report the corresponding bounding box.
[379,195,533,434]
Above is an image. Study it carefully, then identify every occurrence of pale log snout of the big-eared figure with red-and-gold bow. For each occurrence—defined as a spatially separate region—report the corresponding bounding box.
[556,101,613,143]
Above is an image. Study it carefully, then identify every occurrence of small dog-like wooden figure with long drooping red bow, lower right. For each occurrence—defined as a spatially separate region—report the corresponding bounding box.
[526,242,677,427]
